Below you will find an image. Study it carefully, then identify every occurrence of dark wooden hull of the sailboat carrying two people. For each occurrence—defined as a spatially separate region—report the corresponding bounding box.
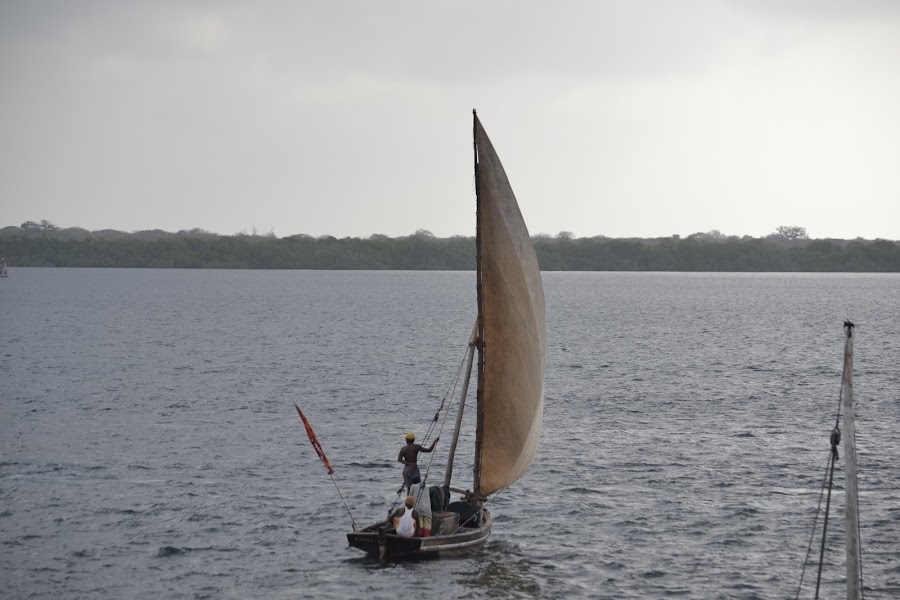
[347,510,493,560]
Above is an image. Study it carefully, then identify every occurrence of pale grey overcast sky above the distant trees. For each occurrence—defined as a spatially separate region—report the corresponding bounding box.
[0,0,900,239]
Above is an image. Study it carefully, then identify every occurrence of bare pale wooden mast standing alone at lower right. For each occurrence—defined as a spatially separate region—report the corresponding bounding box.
[841,321,862,600]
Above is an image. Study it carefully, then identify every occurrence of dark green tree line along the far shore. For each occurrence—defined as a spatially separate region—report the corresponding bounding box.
[0,221,900,273]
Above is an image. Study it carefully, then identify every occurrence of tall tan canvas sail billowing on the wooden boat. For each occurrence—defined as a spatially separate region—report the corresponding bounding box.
[475,117,547,495]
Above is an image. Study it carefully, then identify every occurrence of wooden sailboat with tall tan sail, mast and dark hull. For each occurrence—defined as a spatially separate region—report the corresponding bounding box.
[347,111,547,559]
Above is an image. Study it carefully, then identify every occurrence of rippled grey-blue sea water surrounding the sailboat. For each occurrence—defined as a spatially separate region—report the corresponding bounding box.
[0,269,900,599]
